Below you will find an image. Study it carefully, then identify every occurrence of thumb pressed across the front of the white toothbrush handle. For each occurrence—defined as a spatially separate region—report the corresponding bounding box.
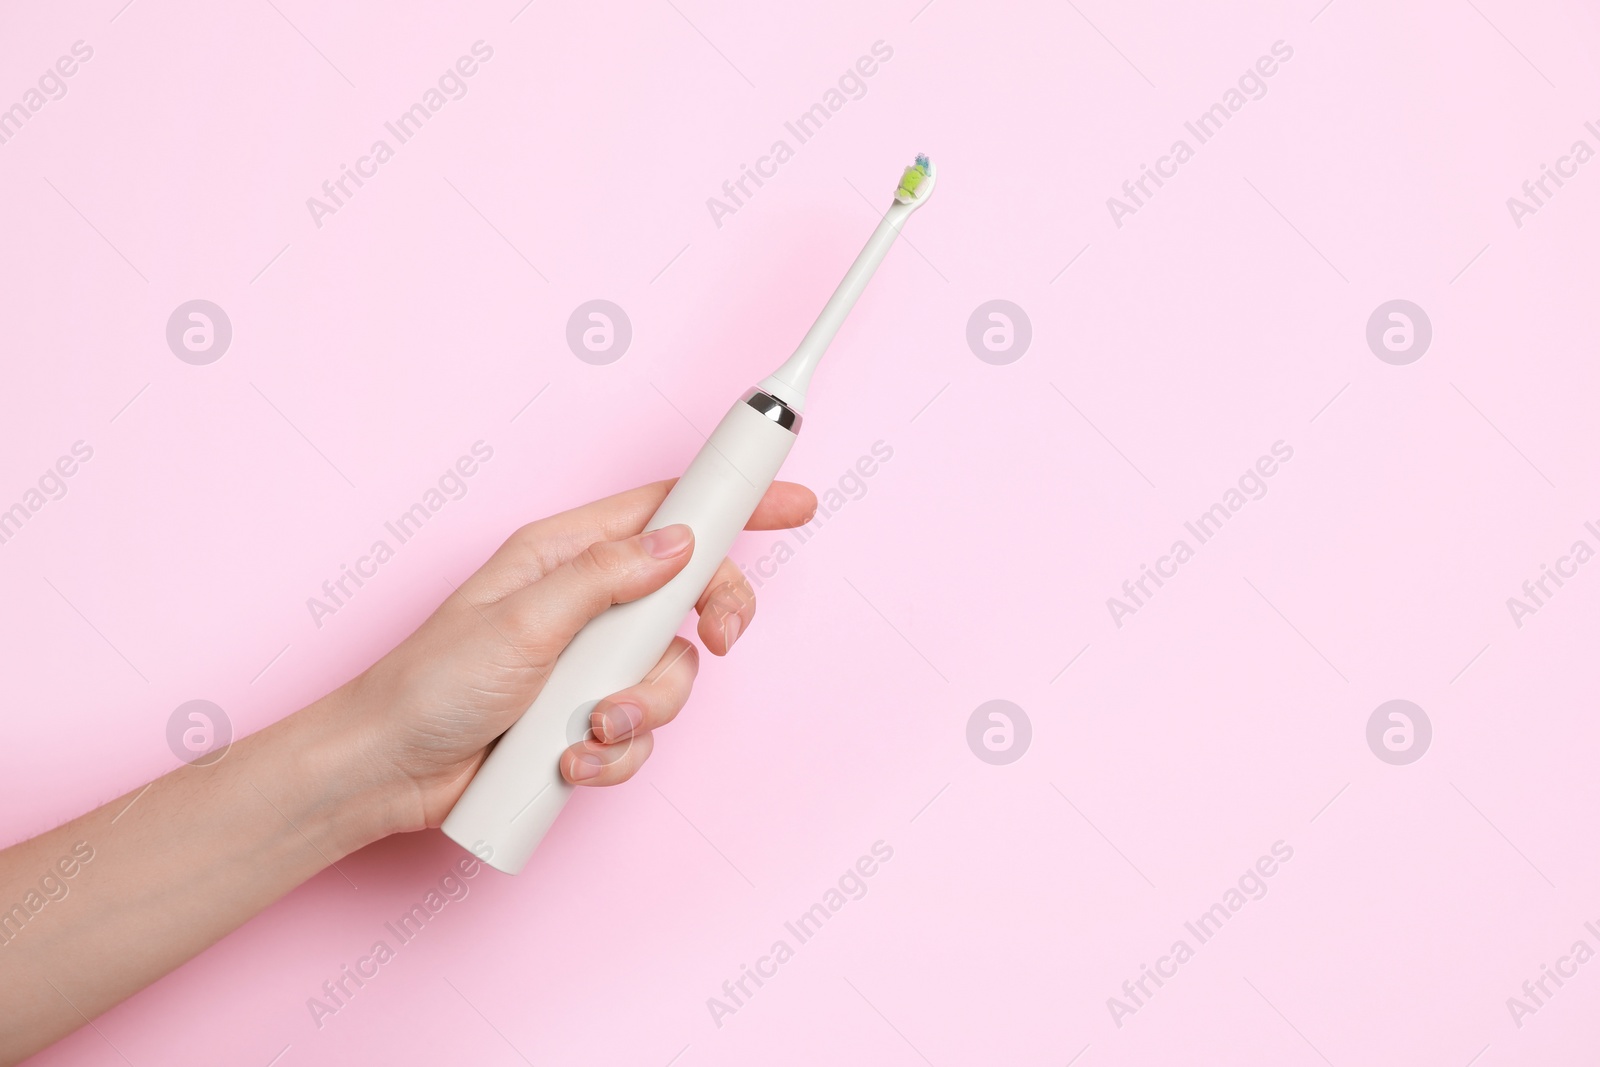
[499,523,694,659]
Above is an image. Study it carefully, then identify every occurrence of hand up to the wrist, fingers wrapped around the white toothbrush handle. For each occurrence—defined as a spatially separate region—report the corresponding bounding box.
[330,482,816,832]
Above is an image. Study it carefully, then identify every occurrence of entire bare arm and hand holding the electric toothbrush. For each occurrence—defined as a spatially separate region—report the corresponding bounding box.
[0,482,816,1064]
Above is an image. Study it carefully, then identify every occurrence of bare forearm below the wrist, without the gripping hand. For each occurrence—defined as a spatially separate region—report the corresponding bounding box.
[0,689,394,1064]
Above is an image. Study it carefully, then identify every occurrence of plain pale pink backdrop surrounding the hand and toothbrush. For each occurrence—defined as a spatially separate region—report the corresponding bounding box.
[0,0,1600,1067]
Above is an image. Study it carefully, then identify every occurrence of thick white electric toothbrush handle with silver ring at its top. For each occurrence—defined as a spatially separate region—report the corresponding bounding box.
[443,390,798,873]
